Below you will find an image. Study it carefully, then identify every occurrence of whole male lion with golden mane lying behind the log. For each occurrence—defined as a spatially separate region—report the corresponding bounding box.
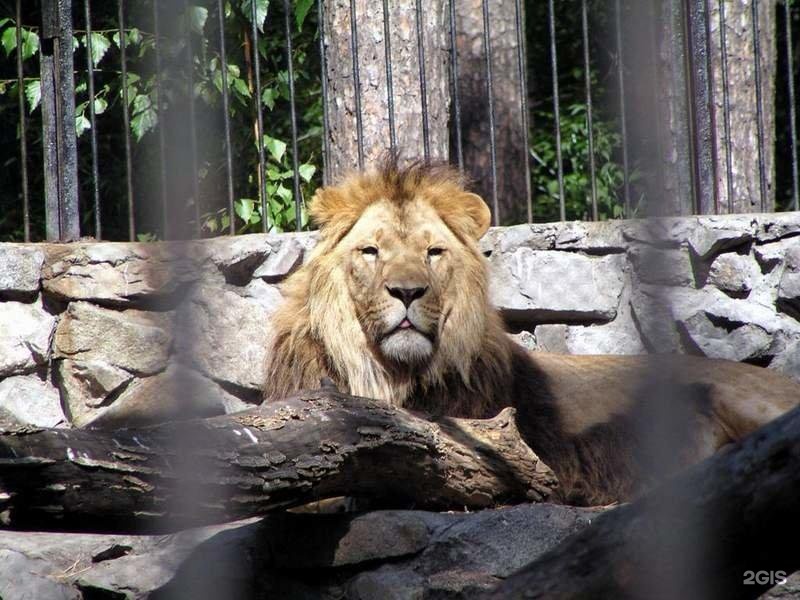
[264,161,800,504]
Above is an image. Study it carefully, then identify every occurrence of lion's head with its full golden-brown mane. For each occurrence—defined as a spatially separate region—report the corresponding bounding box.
[269,161,500,405]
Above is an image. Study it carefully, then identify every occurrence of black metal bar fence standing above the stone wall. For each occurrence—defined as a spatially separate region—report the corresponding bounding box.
[0,0,800,241]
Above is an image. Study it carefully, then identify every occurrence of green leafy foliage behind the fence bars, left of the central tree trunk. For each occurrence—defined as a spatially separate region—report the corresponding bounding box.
[0,0,322,240]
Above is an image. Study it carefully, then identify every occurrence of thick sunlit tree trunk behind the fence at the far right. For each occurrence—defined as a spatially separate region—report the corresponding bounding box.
[650,0,776,215]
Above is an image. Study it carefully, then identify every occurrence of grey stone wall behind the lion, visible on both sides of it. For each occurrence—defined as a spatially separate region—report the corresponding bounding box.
[0,213,800,426]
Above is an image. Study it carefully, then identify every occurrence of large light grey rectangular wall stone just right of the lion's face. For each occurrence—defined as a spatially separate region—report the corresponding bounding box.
[490,248,625,323]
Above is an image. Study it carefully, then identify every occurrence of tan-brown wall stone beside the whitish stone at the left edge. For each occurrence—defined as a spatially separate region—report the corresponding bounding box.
[55,302,172,375]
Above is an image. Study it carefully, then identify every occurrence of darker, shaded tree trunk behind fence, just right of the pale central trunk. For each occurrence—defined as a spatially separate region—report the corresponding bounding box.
[453,0,528,223]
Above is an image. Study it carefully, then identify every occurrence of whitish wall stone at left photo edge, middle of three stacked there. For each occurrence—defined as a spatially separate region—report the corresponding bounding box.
[0,300,56,377]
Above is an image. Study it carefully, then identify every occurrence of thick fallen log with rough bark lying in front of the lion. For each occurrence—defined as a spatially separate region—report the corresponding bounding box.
[0,389,557,532]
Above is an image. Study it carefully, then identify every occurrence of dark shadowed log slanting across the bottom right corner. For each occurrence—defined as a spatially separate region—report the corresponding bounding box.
[488,408,800,600]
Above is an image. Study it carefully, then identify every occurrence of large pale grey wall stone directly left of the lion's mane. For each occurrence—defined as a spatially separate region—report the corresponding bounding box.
[178,286,269,390]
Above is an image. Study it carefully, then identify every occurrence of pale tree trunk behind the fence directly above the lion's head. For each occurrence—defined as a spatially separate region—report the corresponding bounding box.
[325,0,450,181]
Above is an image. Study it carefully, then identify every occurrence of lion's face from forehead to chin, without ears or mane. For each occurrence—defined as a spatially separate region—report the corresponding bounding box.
[339,200,464,365]
